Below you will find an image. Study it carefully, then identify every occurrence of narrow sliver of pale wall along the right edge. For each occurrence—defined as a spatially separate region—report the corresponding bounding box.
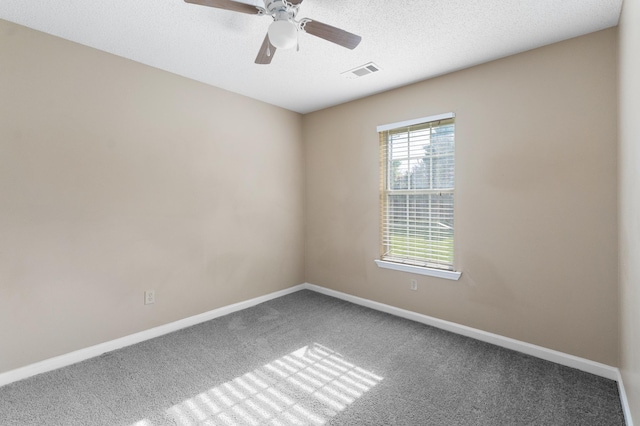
[620,1,640,423]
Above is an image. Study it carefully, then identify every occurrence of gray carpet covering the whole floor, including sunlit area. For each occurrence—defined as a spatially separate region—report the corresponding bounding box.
[0,291,624,426]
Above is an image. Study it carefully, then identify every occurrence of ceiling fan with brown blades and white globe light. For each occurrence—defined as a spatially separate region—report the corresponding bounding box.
[184,0,362,65]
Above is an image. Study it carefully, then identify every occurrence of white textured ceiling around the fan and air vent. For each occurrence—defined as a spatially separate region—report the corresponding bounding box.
[0,0,622,113]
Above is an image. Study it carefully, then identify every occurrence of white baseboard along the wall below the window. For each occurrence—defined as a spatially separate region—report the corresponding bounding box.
[304,283,620,380]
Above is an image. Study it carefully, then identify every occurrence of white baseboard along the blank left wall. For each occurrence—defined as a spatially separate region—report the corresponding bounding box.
[0,284,306,386]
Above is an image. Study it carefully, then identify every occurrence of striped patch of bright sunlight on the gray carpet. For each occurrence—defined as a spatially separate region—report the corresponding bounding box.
[131,343,383,426]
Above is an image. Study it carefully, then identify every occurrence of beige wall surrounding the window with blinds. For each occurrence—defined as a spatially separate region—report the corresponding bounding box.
[303,29,618,365]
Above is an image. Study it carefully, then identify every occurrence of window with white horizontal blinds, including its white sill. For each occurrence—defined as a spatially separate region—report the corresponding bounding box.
[378,113,460,279]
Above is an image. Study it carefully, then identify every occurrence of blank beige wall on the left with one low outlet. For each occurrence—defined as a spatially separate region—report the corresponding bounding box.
[0,21,304,372]
